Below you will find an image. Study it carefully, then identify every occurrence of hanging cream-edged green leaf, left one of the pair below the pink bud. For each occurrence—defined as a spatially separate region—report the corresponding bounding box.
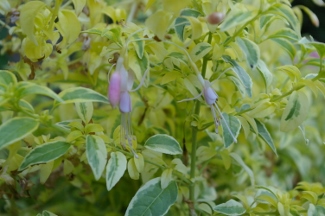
[86,135,107,180]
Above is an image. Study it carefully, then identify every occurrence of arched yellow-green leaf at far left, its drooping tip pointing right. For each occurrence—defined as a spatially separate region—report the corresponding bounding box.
[18,82,63,102]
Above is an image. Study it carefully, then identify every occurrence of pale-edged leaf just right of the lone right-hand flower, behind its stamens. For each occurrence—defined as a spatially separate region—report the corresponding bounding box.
[221,113,241,148]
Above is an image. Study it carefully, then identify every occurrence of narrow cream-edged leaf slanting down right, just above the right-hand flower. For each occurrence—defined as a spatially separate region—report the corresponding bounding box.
[222,55,253,97]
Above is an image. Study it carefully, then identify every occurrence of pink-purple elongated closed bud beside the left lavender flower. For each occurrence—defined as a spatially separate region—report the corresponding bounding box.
[108,72,121,108]
